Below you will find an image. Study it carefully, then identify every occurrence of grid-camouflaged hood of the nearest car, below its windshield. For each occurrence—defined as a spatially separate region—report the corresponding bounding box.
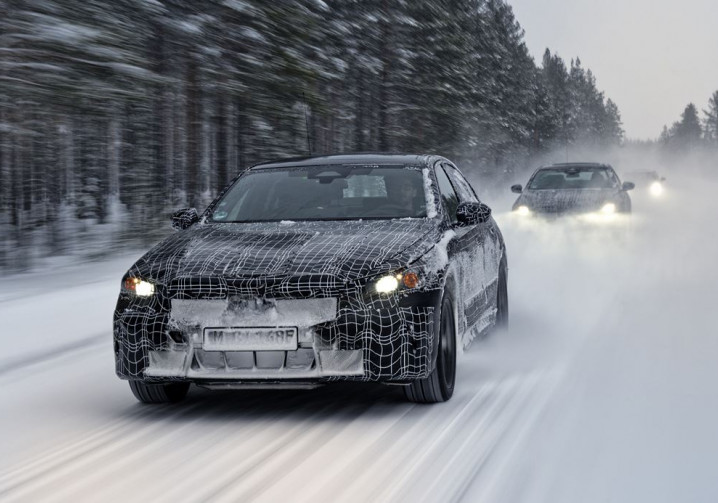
[128,219,440,284]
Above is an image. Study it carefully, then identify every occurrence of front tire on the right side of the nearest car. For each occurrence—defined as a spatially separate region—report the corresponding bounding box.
[404,295,456,403]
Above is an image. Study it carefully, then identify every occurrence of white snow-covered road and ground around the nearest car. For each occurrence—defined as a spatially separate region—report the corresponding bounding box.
[0,172,718,503]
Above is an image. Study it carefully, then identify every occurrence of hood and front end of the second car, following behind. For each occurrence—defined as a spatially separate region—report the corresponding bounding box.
[514,189,619,213]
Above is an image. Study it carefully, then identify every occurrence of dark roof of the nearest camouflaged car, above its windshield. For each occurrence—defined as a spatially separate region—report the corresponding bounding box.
[250,153,442,170]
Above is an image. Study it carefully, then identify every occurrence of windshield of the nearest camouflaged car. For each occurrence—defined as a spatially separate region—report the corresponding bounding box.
[210,165,426,222]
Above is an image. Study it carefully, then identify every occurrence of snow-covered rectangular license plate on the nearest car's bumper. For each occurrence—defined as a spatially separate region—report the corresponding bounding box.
[202,327,297,351]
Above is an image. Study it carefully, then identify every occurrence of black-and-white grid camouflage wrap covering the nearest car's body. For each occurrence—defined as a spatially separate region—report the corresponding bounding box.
[114,156,503,382]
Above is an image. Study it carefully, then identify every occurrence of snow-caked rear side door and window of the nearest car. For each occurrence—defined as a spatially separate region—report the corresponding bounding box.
[444,162,502,338]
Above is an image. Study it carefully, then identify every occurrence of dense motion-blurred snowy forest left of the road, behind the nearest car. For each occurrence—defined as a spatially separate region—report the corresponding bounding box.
[0,0,623,270]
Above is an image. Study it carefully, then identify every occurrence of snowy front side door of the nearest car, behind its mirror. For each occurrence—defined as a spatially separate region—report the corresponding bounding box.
[435,161,485,345]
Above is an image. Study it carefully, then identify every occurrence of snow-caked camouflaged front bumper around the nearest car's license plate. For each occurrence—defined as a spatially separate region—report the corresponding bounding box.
[114,290,440,384]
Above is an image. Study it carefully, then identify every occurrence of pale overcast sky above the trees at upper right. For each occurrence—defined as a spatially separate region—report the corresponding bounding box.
[508,0,718,139]
